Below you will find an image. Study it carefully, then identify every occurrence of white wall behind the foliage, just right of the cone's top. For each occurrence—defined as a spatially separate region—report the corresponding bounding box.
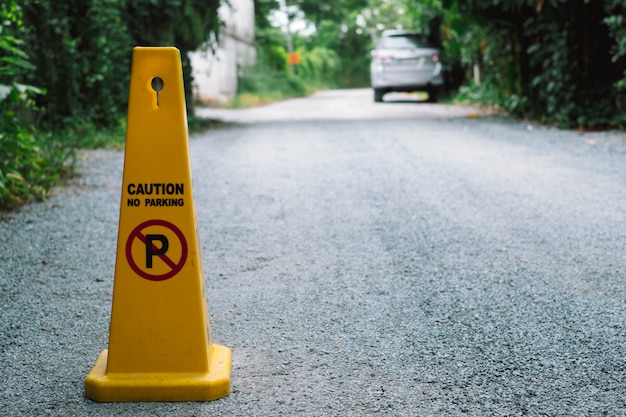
[189,0,256,103]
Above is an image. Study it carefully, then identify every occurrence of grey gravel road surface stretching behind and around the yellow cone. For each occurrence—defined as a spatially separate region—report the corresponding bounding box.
[0,90,626,417]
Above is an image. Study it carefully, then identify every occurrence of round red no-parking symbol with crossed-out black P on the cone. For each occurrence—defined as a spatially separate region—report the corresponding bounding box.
[126,219,188,281]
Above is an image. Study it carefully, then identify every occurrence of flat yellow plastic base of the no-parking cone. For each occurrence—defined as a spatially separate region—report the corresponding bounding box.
[85,345,231,402]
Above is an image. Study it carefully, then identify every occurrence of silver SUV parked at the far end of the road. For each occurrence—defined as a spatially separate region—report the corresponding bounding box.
[371,30,444,102]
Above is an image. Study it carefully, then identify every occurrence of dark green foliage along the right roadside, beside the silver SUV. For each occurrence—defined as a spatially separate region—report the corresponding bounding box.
[442,0,626,127]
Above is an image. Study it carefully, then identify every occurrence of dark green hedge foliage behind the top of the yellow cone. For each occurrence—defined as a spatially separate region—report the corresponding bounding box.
[24,0,220,130]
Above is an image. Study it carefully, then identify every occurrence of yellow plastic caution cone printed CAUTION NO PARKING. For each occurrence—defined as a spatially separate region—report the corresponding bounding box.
[85,47,231,402]
